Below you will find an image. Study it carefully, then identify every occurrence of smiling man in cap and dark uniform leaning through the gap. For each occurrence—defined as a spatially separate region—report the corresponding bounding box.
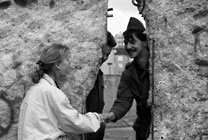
[106,17,151,140]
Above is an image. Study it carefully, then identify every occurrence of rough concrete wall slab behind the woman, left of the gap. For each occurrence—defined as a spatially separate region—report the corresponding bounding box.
[0,0,107,140]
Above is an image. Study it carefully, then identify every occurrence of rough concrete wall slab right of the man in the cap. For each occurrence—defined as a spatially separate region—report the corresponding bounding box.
[143,0,208,140]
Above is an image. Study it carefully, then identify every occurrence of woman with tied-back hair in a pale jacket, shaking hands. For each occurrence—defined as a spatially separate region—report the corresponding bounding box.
[18,44,103,140]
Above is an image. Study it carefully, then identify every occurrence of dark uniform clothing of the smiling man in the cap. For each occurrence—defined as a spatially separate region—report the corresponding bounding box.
[110,61,151,140]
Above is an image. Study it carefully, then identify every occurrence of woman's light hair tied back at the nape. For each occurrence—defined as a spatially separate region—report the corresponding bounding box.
[31,44,68,83]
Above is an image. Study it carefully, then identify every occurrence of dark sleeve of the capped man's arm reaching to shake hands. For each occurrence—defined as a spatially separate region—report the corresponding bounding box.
[110,72,134,122]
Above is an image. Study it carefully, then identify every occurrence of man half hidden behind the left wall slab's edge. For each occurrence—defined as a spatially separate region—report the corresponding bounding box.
[86,32,116,140]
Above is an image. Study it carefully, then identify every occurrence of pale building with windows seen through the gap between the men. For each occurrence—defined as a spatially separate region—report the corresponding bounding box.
[101,33,131,75]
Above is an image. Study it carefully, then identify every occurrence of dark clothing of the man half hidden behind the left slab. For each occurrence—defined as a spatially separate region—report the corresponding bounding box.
[86,70,105,140]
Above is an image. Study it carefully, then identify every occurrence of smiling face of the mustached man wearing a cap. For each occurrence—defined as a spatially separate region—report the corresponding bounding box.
[124,34,145,58]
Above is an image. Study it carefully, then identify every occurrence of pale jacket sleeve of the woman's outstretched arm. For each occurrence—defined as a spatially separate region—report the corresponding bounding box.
[45,89,100,134]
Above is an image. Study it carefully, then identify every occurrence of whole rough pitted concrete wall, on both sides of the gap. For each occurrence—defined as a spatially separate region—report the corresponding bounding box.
[0,0,208,140]
